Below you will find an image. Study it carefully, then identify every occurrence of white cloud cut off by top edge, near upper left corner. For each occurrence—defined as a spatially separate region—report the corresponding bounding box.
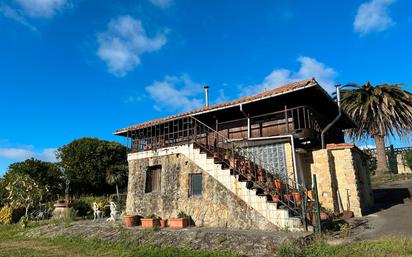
[15,0,70,18]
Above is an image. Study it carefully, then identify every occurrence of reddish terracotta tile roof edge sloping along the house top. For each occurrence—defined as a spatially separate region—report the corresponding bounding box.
[115,78,318,134]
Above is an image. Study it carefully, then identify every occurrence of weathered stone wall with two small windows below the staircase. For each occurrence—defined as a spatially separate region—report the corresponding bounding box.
[126,154,277,230]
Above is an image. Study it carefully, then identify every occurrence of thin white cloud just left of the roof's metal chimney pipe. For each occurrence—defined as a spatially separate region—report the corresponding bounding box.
[146,75,204,111]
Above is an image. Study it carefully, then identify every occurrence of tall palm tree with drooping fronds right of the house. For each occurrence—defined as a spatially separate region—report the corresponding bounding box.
[341,82,412,176]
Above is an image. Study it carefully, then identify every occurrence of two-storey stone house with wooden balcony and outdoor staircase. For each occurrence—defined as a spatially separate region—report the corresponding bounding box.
[115,79,373,230]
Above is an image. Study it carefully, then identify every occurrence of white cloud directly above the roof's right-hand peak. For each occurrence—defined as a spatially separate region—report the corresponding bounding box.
[241,56,337,96]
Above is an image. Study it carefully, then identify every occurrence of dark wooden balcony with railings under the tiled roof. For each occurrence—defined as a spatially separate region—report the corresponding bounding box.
[129,106,327,152]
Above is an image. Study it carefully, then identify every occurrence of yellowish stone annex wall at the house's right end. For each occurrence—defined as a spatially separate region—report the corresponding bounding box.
[311,144,373,216]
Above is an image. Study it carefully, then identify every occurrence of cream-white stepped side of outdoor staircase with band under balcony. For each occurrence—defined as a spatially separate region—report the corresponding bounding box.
[128,144,304,231]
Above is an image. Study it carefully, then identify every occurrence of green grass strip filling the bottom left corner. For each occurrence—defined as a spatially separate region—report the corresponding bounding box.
[0,224,238,257]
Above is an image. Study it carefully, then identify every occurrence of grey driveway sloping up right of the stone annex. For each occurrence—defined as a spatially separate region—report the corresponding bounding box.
[354,179,412,239]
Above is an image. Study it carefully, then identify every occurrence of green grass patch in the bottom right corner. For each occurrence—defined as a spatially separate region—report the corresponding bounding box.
[277,237,412,257]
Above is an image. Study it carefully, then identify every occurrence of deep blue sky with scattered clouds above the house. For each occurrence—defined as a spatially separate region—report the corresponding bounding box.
[0,0,412,175]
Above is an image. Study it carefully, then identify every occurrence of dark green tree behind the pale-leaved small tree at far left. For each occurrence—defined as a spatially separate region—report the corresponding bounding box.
[4,158,64,200]
